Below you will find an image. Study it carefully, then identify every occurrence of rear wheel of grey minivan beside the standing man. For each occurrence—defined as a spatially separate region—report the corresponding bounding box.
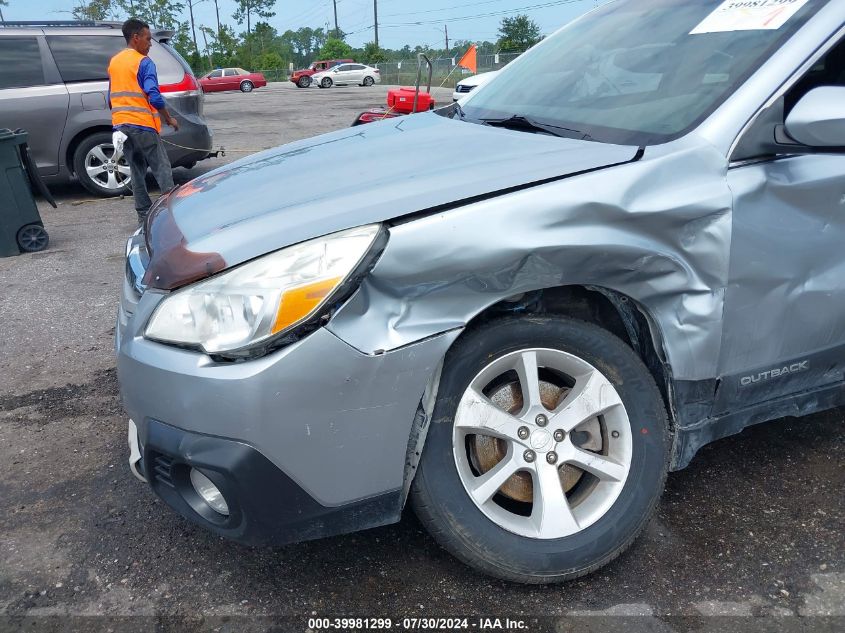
[73,132,132,197]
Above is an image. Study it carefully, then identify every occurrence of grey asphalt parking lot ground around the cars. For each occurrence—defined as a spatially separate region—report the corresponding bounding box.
[0,84,845,631]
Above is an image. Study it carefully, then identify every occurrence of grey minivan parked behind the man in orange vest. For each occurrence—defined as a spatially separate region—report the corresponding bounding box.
[0,22,212,196]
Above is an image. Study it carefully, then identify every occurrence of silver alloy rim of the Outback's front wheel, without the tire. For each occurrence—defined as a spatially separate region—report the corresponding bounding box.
[452,348,632,539]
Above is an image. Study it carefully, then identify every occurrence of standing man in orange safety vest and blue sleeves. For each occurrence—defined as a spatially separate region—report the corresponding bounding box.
[109,18,179,223]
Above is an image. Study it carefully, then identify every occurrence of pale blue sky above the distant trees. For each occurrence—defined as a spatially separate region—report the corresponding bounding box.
[3,0,602,48]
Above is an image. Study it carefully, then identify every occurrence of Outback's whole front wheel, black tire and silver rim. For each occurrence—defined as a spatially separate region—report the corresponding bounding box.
[411,316,669,584]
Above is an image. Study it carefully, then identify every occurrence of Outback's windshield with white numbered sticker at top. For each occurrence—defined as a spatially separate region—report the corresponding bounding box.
[463,0,828,146]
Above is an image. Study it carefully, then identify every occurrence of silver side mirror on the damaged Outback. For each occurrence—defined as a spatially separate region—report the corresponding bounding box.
[784,86,845,147]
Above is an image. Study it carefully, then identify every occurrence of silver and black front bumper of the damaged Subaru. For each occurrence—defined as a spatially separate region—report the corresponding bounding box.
[115,272,457,543]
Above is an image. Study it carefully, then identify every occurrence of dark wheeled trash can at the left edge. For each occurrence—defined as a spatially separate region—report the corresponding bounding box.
[0,129,56,257]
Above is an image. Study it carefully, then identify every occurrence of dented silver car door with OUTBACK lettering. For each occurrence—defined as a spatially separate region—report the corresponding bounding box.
[714,34,845,414]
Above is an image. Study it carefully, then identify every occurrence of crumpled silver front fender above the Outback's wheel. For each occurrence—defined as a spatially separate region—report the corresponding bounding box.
[329,142,731,380]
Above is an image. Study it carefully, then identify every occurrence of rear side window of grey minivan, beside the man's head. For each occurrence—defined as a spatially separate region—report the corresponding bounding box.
[47,35,126,83]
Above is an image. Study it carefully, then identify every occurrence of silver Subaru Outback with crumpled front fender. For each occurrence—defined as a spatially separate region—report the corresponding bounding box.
[116,0,845,583]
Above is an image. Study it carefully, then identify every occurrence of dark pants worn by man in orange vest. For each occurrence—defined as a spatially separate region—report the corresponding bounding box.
[120,126,173,222]
